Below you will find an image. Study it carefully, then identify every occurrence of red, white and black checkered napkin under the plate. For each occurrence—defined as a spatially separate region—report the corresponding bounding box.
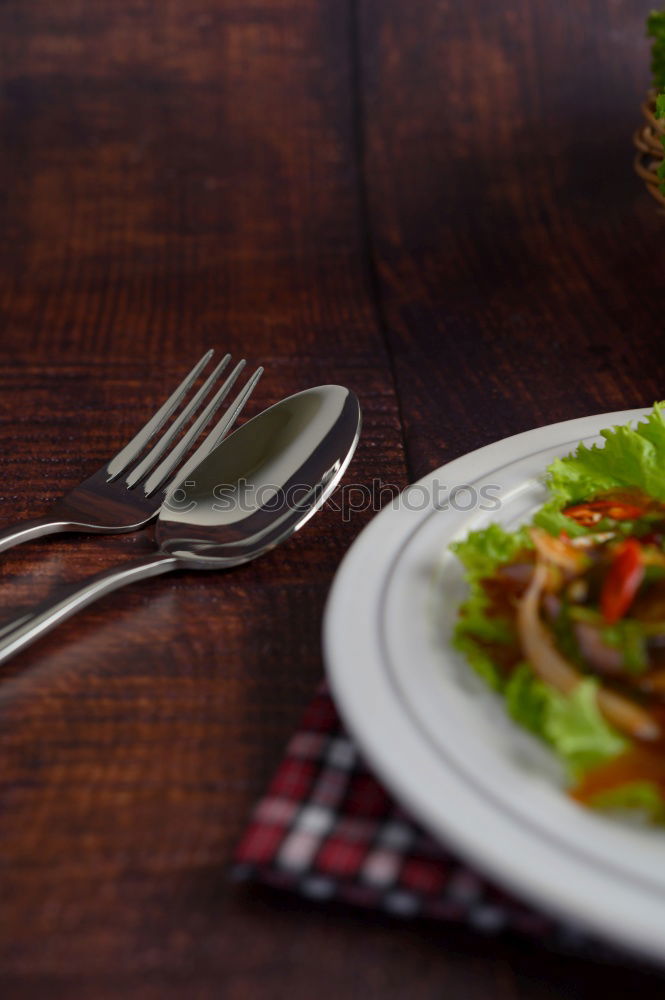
[232,687,604,955]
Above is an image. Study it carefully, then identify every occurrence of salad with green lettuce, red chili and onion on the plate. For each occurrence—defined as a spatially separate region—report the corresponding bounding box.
[452,403,665,822]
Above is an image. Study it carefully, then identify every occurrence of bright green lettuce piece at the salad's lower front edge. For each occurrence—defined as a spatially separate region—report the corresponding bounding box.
[505,664,627,779]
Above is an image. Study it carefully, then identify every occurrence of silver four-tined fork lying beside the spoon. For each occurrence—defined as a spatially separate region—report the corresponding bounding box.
[0,351,263,552]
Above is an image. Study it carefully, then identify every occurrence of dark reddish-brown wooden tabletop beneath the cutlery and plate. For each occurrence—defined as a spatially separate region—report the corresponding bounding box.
[0,0,665,1000]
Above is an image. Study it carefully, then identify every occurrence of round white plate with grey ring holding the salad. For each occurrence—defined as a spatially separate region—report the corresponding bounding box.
[324,410,665,959]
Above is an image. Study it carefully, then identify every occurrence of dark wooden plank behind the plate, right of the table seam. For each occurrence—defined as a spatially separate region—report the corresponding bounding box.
[359,0,665,476]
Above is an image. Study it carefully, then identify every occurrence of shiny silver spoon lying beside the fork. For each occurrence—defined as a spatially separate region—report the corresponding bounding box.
[0,385,361,663]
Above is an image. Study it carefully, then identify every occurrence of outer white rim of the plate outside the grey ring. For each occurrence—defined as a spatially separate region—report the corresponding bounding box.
[323,407,665,961]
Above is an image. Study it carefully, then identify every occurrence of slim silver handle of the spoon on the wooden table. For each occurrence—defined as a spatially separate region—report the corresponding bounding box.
[0,552,179,663]
